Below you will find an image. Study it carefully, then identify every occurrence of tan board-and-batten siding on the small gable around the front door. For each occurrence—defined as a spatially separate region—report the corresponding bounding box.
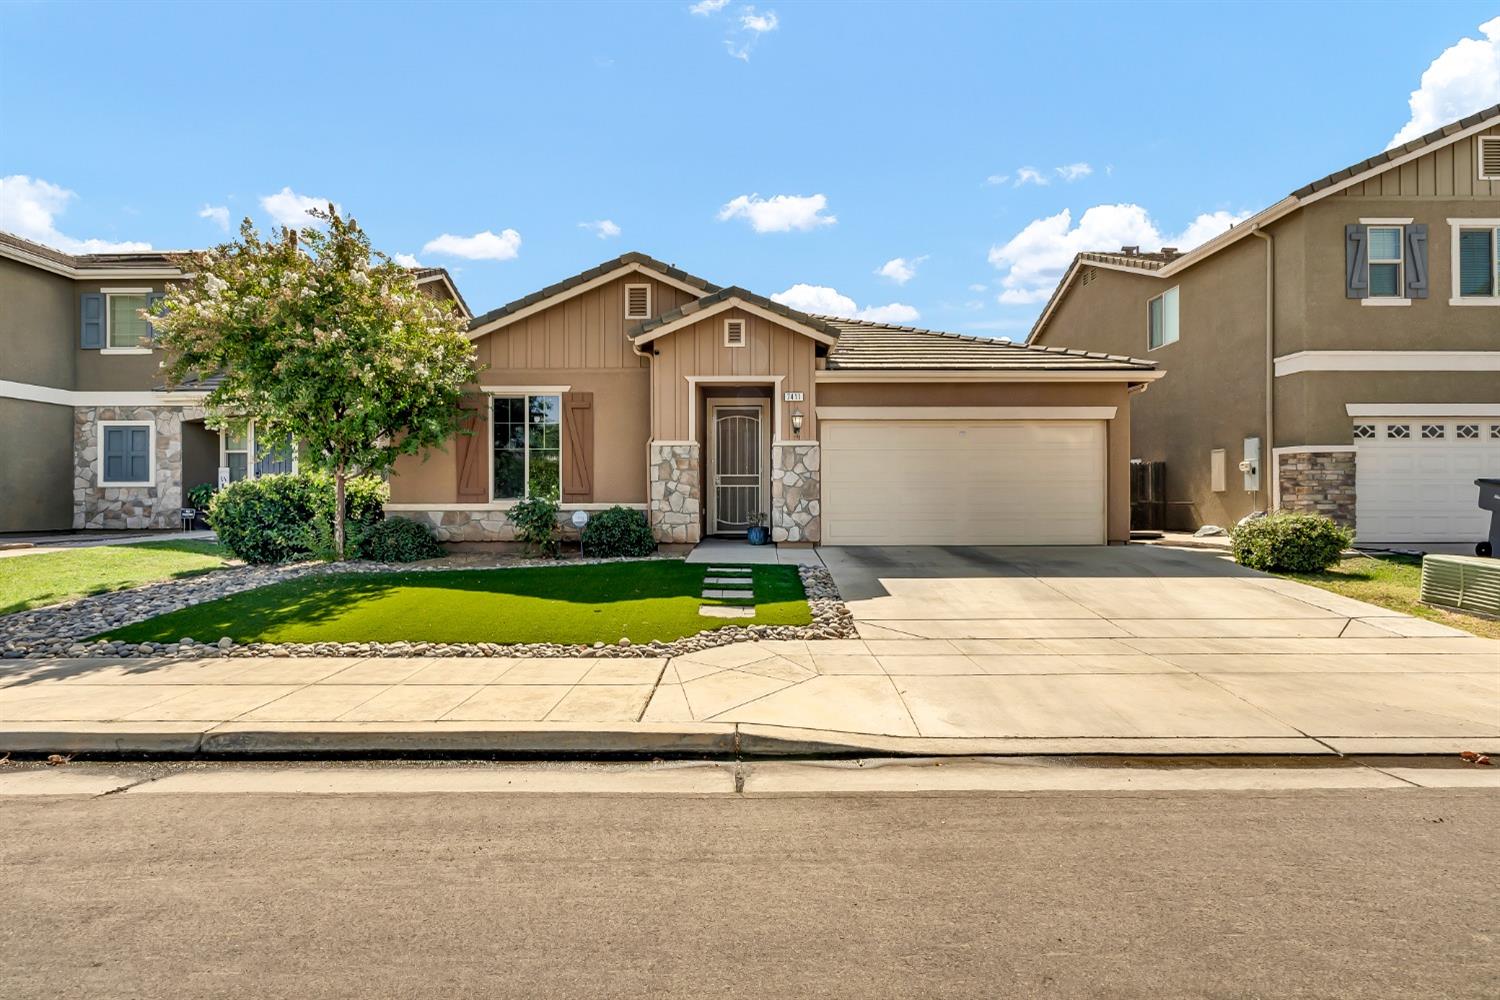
[651,309,818,441]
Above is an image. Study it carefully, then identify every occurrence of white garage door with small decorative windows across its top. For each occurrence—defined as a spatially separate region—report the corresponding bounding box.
[1355,417,1500,544]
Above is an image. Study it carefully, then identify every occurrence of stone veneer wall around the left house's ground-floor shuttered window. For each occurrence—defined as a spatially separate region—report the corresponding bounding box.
[74,406,203,528]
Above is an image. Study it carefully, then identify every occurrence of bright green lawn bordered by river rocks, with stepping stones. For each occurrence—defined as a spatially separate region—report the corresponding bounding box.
[107,561,812,643]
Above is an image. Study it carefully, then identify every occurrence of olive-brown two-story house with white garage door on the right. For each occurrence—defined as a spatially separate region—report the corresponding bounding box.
[1028,105,1500,544]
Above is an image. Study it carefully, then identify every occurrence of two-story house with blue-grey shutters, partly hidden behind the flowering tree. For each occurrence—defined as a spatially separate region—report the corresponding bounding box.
[0,232,468,532]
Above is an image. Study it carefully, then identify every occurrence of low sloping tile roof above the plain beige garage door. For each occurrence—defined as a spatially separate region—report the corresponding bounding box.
[819,316,1157,372]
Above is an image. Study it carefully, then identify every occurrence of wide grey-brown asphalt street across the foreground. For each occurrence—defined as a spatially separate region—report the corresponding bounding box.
[0,787,1500,1000]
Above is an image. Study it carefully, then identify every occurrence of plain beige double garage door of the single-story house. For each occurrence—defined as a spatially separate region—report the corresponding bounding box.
[821,420,1106,546]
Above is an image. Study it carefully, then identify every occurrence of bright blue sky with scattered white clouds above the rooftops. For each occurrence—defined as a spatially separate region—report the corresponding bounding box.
[0,0,1500,337]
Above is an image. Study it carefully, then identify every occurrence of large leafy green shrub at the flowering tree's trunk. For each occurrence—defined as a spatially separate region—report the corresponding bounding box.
[209,472,390,564]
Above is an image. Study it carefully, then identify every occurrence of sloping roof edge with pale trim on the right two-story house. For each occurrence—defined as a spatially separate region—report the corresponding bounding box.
[1026,103,1500,343]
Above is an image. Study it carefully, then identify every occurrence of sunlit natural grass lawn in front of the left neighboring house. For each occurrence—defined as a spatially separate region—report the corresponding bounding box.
[0,541,228,615]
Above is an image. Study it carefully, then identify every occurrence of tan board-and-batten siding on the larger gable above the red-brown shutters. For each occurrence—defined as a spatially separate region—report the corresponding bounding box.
[474,274,695,371]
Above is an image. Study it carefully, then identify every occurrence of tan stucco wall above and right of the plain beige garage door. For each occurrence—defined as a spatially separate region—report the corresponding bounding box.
[818,379,1134,543]
